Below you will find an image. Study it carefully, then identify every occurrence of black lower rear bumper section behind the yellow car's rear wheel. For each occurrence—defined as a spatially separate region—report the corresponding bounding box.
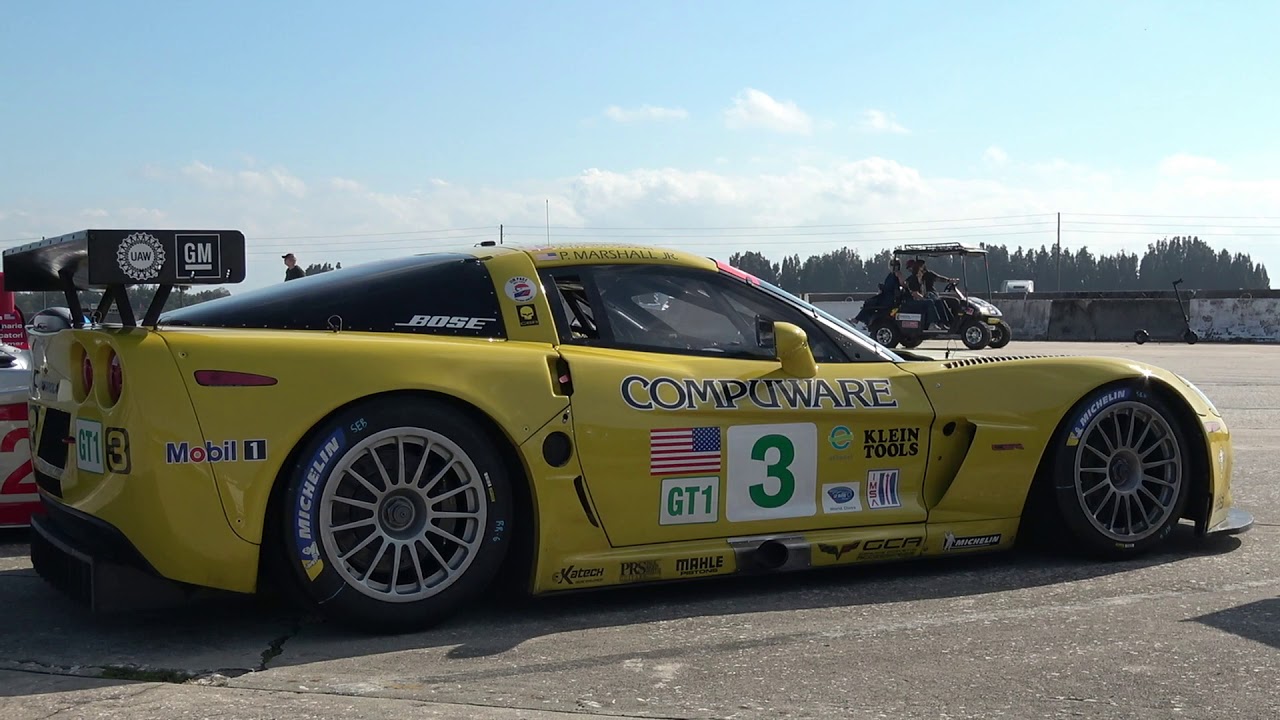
[31,498,195,612]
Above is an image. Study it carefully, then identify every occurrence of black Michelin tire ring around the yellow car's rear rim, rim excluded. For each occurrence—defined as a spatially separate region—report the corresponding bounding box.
[282,398,513,629]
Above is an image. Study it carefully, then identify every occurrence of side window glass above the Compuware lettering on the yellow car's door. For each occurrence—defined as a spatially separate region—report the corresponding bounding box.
[544,265,847,363]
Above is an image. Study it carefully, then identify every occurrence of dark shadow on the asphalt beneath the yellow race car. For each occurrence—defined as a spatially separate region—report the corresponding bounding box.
[0,525,1244,697]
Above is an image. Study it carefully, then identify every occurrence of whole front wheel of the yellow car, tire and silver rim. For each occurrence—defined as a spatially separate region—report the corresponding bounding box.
[1053,383,1192,559]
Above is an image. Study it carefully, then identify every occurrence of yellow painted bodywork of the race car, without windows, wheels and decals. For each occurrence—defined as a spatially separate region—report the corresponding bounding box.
[24,245,1231,593]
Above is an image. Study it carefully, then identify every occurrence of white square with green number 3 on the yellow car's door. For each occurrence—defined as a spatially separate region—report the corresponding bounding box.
[724,423,818,523]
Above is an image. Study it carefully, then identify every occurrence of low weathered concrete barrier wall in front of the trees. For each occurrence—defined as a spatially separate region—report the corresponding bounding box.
[812,292,1280,342]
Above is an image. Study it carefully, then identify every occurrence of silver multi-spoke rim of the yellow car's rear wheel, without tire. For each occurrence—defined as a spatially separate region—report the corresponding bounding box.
[319,428,488,602]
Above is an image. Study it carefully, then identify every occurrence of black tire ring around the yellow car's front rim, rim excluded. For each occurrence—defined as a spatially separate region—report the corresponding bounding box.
[1052,382,1193,557]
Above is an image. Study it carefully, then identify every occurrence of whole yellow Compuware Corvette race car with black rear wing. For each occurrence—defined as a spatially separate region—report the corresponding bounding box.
[4,231,1252,632]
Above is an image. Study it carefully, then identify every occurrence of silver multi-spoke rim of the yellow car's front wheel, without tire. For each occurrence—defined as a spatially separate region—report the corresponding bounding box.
[1075,402,1183,542]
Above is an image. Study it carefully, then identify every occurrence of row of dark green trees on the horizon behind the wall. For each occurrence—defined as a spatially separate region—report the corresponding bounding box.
[728,236,1271,293]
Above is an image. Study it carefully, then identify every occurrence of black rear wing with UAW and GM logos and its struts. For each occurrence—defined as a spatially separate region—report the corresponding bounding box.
[4,229,246,328]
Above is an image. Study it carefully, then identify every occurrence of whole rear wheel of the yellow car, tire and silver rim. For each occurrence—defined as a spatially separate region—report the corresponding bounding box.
[283,398,513,633]
